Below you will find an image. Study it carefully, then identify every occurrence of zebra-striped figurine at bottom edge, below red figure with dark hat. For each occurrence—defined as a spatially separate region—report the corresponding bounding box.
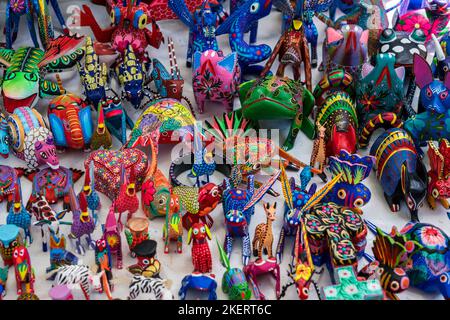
[128,275,174,300]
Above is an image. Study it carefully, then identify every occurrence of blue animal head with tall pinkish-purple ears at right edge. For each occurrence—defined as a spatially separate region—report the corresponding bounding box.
[413,54,450,114]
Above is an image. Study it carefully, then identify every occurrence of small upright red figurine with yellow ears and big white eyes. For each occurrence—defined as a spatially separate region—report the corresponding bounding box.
[188,222,212,273]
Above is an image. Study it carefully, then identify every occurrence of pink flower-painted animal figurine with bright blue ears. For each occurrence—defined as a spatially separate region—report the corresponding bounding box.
[192,50,241,113]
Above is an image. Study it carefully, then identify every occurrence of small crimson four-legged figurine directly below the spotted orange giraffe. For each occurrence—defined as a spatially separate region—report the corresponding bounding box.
[244,258,280,300]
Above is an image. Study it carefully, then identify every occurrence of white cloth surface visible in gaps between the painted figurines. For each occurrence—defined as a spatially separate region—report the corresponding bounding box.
[0,0,450,299]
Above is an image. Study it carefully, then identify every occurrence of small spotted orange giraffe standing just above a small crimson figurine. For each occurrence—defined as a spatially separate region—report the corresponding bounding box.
[252,202,277,259]
